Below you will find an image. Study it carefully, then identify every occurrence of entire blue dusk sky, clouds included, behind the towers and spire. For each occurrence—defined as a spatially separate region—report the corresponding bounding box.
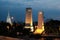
[0,0,60,21]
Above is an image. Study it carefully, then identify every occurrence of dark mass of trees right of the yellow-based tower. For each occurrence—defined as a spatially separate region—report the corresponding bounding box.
[45,19,60,35]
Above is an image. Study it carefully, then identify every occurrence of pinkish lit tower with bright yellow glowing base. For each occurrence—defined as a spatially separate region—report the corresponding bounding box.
[34,11,44,34]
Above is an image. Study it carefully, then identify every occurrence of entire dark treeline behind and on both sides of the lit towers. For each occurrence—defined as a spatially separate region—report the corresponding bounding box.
[0,19,60,37]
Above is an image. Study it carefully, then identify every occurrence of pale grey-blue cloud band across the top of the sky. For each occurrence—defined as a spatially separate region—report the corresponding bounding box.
[1,0,60,9]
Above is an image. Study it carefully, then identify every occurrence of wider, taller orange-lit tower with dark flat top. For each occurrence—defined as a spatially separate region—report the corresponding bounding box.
[25,8,33,32]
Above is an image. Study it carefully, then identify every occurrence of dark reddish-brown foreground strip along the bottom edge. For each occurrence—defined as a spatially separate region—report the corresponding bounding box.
[0,36,60,40]
